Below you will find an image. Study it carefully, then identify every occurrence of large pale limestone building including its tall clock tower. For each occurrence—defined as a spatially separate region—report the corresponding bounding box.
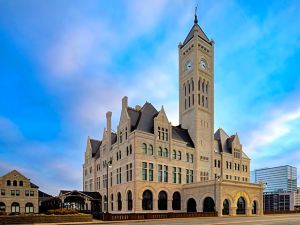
[83,15,263,216]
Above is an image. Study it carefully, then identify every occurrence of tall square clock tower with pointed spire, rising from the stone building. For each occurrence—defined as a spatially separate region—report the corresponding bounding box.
[178,14,214,182]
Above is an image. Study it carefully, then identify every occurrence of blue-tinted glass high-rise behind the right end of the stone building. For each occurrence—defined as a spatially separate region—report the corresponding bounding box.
[251,165,297,192]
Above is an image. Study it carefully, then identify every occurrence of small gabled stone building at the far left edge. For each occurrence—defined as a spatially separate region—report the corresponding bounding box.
[0,170,39,214]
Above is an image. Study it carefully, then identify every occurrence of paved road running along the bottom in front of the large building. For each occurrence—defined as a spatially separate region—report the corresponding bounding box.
[91,214,300,225]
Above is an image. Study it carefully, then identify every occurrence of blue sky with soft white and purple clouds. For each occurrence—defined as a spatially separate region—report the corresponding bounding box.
[0,0,300,194]
